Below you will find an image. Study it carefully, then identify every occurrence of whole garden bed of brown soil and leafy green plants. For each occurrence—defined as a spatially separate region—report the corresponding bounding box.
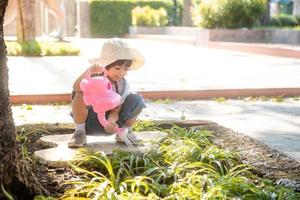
[17,121,300,199]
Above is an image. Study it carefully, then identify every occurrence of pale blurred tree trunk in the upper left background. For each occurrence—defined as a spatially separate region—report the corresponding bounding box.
[17,0,36,42]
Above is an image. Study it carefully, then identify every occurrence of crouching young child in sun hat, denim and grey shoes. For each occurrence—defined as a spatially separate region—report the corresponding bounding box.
[68,39,145,147]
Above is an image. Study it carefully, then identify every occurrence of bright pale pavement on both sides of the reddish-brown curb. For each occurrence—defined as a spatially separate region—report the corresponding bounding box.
[8,39,300,160]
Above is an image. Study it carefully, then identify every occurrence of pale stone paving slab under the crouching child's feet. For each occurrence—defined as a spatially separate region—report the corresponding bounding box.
[34,131,167,167]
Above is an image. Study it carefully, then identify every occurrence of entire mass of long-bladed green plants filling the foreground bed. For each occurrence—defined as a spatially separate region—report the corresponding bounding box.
[63,123,300,199]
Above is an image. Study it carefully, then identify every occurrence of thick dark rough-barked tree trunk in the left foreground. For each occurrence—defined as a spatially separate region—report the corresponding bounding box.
[0,0,45,199]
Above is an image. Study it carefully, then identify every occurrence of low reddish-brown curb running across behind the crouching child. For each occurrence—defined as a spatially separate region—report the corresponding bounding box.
[10,88,300,105]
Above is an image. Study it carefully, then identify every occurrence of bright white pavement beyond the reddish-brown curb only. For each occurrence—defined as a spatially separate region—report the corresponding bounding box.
[8,39,300,95]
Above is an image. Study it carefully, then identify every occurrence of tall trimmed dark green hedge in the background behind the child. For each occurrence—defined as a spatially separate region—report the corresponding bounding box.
[90,0,182,37]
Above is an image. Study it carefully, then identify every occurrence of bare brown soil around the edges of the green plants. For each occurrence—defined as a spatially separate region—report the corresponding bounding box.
[17,121,300,196]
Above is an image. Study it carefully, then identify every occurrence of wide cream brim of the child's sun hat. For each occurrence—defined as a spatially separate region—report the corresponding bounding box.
[89,48,145,70]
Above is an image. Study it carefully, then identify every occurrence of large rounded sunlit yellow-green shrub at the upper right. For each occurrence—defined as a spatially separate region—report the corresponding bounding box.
[193,0,266,28]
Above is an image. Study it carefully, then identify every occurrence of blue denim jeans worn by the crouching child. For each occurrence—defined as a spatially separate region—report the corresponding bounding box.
[85,93,146,135]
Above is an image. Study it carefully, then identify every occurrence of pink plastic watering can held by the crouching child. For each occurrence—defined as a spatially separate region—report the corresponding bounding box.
[80,69,137,146]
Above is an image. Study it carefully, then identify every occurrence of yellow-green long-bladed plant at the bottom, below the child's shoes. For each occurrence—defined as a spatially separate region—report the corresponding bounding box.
[63,151,157,199]
